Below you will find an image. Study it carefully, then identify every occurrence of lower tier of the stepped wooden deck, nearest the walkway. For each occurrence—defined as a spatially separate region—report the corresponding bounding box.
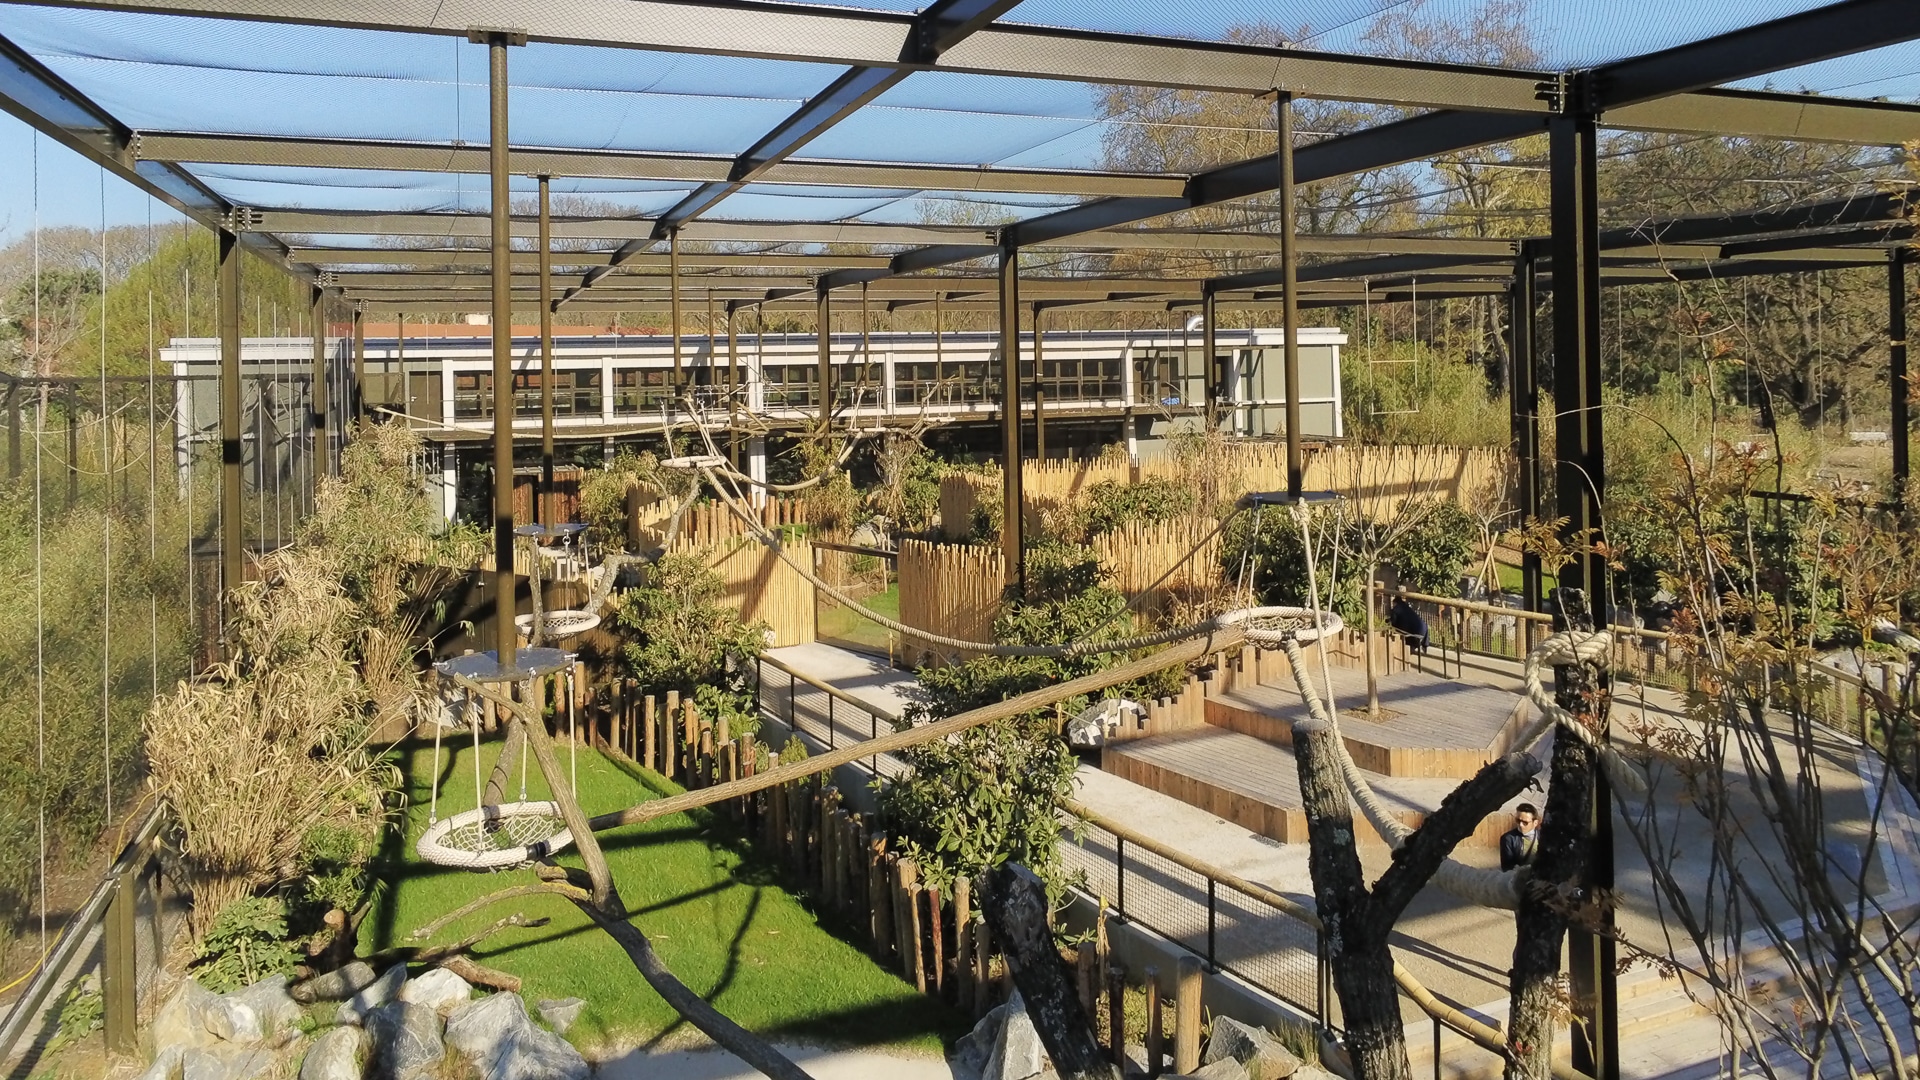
[1100,728,1513,847]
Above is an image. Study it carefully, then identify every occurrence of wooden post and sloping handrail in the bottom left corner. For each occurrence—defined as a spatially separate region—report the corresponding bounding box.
[0,811,182,1063]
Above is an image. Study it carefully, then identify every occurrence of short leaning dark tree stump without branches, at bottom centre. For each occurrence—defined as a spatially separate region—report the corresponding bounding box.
[985,863,1121,1080]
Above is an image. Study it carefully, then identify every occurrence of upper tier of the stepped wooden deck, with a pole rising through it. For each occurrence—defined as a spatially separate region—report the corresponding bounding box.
[1206,667,1526,780]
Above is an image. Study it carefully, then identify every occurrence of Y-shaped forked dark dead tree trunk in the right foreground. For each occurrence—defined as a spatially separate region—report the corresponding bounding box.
[1294,721,1540,1080]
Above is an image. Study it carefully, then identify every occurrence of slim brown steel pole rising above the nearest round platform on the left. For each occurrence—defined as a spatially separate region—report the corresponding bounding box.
[486,33,520,669]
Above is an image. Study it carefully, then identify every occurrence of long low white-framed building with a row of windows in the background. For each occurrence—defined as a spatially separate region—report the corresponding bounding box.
[161,325,1346,517]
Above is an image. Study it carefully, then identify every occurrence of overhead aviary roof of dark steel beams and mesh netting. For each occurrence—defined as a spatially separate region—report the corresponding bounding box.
[0,0,1920,311]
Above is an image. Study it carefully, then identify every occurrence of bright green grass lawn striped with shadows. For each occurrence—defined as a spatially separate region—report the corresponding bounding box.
[361,736,968,1051]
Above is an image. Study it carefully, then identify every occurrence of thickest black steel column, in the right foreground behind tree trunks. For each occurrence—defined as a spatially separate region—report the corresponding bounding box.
[1548,100,1620,1080]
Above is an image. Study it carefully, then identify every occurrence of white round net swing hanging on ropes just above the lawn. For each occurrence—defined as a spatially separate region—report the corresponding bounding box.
[413,650,578,871]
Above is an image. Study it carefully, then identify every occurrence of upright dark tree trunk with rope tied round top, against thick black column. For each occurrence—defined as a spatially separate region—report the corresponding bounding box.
[1507,590,1607,1080]
